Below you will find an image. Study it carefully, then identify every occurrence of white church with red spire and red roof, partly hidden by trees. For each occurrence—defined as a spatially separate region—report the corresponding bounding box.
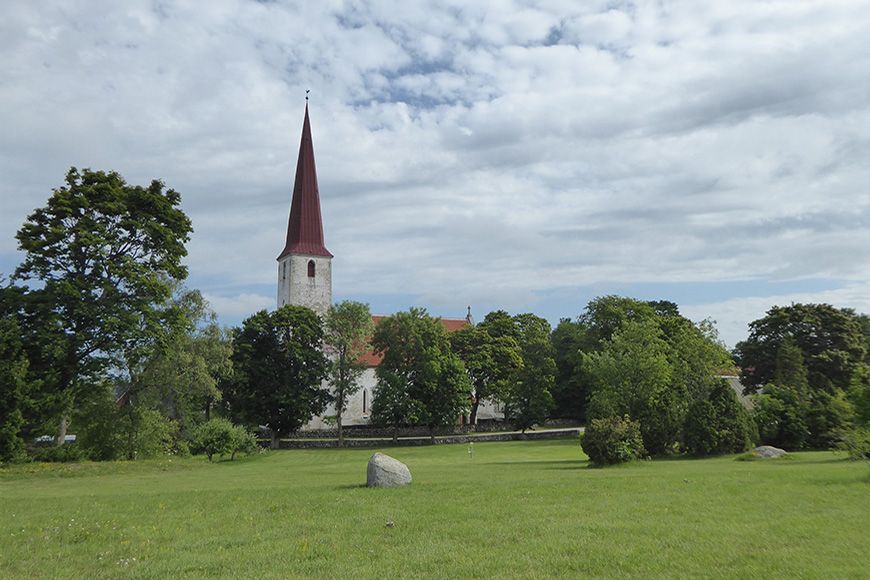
[278,101,504,430]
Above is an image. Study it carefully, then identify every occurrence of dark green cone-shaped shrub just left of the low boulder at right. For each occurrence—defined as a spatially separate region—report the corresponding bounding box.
[684,381,757,455]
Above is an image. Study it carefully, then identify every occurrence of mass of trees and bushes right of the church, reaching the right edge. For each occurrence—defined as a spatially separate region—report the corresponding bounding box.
[552,296,870,463]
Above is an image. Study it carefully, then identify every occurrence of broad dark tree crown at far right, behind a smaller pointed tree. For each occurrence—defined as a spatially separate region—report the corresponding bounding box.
[735,304,867,394]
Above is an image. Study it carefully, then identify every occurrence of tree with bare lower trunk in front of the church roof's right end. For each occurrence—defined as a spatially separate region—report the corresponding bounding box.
[450,313,523,425]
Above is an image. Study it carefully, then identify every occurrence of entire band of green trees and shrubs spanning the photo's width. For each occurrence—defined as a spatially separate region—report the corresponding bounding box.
[0,169,870,463]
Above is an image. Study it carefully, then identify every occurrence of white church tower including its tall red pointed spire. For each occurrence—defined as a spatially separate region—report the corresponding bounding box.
[278,103,332,315]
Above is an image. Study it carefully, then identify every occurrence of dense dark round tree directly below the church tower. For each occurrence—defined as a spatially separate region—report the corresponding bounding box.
[224,306,330,448]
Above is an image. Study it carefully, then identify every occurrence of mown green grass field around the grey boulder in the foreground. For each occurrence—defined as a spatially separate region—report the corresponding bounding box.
[0,441,870,578]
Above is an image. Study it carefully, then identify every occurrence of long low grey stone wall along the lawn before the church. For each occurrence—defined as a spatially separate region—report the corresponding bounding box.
[280,428,581,449]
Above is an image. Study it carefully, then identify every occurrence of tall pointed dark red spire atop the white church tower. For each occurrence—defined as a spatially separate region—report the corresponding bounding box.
[278,103,332,260]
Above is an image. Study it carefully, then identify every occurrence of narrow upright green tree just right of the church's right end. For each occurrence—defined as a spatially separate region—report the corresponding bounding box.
[505,314,556,432]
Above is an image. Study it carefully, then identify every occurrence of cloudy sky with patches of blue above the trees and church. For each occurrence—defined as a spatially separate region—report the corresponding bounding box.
[0,0,870,345]
